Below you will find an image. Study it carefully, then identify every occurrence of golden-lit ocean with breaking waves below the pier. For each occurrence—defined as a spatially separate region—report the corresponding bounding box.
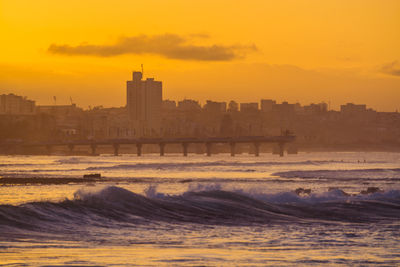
[0,152,400,266]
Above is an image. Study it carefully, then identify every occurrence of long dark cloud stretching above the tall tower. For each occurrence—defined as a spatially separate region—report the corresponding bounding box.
[48,34,257,61]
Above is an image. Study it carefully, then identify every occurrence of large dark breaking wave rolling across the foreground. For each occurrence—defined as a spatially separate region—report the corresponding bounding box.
[0,186,400,233]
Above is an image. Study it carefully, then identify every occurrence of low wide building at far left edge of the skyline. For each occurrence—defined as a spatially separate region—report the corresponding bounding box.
[0,94,36,115]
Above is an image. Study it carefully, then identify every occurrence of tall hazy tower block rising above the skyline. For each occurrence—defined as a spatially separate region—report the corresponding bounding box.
[126,71,162,137]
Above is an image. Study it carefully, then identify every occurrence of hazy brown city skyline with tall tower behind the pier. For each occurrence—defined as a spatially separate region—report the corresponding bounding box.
[0,70,400,154]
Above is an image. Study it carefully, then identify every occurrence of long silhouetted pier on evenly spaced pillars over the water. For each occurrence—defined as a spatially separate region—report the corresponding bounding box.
[18,135,296,157]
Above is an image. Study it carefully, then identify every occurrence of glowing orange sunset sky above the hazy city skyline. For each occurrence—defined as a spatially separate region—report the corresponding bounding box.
[0,0,400,111]
